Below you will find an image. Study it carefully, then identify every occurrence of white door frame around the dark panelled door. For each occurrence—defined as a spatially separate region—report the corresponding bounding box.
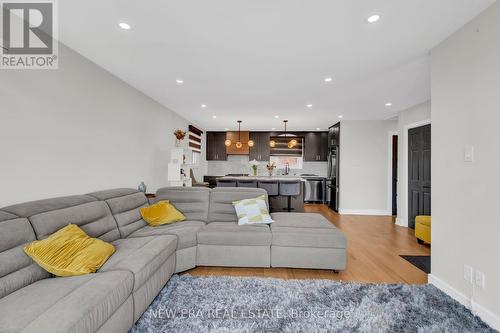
[396,119,432,228]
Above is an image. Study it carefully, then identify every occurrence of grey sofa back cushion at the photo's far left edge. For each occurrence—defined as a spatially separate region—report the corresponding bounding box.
[0,211,50,296]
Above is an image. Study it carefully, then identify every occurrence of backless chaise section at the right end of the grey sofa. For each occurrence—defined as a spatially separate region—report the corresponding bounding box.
[271,213,347,271]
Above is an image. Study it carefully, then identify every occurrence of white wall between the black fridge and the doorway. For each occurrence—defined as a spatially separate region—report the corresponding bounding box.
[340,120,397,215]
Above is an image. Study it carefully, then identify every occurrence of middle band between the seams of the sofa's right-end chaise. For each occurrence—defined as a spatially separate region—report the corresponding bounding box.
[271,225,347,249]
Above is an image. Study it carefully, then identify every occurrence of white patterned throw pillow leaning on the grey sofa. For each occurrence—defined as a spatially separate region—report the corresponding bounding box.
[233,195,274,225]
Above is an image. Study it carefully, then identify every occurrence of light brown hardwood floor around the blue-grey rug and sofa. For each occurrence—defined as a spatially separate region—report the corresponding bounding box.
[186,205,430,284]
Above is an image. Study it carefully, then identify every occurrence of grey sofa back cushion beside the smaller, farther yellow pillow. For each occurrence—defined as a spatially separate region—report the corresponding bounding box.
[156,187,210,222]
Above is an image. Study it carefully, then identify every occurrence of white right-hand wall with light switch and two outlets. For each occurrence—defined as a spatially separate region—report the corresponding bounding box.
[431,2,500,329]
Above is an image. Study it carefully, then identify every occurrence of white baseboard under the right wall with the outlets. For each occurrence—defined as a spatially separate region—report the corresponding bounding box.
[427,274,500,330]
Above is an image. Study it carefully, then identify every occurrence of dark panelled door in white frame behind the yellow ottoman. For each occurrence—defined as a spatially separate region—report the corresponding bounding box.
[408,125,431,228]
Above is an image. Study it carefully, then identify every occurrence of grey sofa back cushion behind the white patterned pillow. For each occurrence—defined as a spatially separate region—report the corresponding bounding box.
[208,187,269,223]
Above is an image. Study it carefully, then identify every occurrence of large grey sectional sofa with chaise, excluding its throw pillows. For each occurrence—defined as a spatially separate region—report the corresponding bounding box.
[0,187,346,332]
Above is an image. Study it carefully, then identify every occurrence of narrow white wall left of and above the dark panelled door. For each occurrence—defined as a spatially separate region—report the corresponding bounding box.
[397,101,431,226]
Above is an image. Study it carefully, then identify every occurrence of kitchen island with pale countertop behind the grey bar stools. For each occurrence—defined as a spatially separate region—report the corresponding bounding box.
[218,176,305,213]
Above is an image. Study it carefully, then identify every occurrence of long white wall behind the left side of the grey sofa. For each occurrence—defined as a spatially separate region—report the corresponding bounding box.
[0,45,204,207]
